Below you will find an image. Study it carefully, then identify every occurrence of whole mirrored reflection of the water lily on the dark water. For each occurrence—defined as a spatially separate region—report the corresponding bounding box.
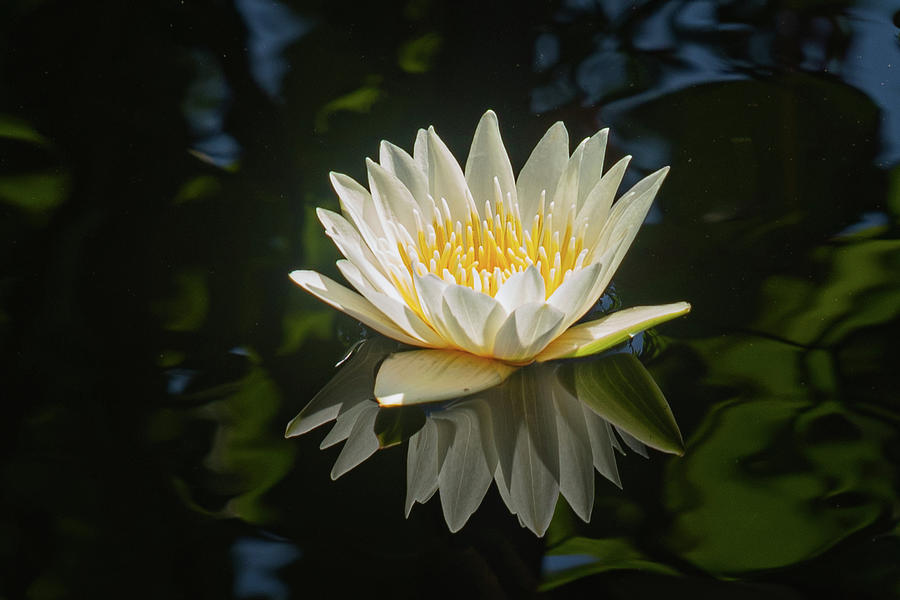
[286,337,683,535]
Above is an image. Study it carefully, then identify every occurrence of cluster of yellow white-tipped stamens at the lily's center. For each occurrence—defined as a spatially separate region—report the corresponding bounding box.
[395,190,588,308]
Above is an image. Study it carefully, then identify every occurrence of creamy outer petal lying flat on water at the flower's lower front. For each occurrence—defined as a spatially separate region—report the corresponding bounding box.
[375,350,516,406]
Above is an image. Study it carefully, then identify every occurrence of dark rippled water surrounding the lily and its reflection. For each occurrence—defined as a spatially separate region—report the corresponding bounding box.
[0,0,900,600]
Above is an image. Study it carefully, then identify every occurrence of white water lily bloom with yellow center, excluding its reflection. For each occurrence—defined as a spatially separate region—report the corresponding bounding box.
[291,110,690,405]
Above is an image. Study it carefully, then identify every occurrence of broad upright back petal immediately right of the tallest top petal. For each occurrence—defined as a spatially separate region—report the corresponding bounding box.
[516,121,569,223]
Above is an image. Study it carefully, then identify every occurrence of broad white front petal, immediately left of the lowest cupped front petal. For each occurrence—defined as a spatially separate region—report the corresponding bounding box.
[442,284,506,356]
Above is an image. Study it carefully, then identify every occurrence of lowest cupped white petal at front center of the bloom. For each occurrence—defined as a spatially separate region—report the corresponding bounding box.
[494,302,566,362]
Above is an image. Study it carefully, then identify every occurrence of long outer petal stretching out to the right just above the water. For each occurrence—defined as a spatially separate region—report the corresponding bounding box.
[536,302,691,362]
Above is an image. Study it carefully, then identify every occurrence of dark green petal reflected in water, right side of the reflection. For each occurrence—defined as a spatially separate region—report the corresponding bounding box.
[575,354,684,455]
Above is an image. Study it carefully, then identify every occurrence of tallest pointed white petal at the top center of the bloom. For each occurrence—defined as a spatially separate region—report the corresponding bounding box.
[466,110,516,208]
